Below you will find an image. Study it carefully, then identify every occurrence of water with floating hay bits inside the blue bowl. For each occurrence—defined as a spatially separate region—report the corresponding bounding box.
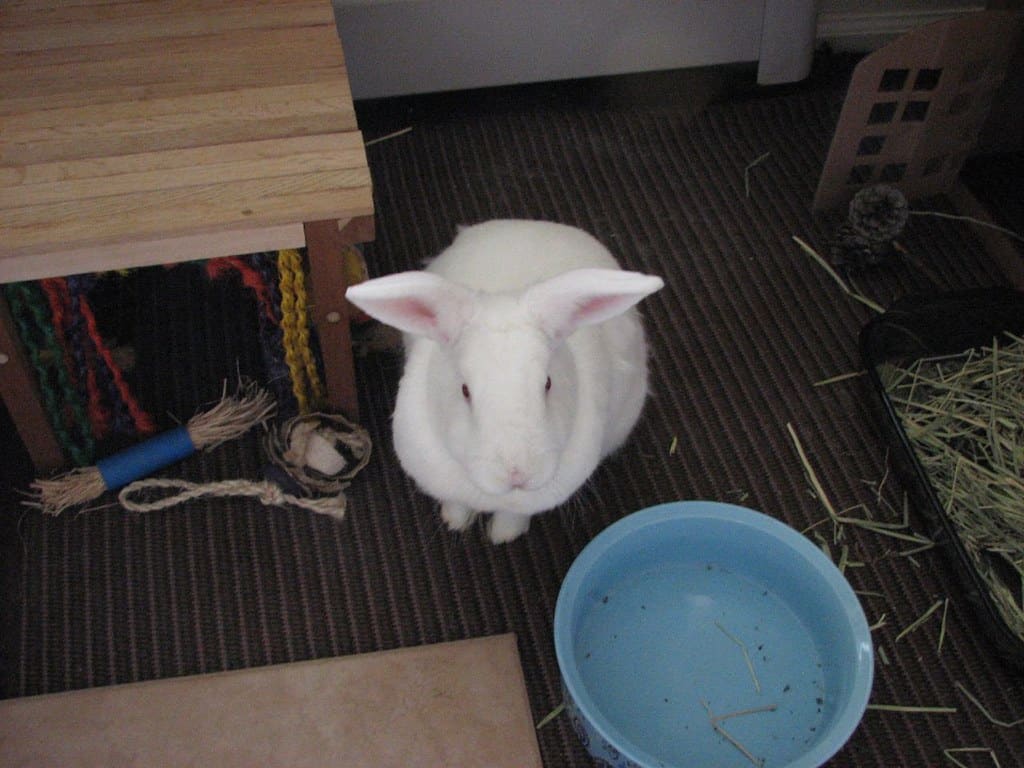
[574,562,830,768]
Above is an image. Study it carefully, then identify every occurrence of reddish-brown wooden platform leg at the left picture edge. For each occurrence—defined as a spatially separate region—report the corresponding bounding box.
[0,295,66,474]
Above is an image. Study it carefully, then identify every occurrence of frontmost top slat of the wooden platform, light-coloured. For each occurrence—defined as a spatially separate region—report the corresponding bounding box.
[0,174,373,259]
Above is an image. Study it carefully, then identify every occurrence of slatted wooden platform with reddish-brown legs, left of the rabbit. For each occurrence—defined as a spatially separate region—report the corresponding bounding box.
[0,0,373,469]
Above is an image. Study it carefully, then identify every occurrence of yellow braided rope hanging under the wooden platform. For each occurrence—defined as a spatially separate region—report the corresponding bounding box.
[278,249,324,414]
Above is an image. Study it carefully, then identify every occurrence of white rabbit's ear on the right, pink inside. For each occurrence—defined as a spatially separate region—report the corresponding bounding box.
[522,269,665,339]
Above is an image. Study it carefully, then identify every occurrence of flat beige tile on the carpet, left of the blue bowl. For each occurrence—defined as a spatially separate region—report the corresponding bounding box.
[0,638,544,768]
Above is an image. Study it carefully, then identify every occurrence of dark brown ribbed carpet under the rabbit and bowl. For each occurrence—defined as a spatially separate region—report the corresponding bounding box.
[0,73,1024,768]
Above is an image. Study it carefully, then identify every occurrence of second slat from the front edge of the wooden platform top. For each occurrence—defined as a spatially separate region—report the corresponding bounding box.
[0,131,367,209]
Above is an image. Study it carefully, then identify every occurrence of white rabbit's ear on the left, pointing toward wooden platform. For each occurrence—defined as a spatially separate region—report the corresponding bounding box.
[345,271,474,344]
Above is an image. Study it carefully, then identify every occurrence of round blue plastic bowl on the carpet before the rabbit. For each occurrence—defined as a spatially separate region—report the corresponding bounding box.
[555,502,874,768]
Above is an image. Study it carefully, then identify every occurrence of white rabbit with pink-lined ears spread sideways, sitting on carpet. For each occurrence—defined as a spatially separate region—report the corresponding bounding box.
[346,220,664,544]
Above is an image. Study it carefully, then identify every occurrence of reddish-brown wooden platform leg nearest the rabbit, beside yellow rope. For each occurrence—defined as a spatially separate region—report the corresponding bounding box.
[304,216,373,421]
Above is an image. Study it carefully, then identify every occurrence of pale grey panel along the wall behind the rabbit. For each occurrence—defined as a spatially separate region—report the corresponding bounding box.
[334,0,816,98]
